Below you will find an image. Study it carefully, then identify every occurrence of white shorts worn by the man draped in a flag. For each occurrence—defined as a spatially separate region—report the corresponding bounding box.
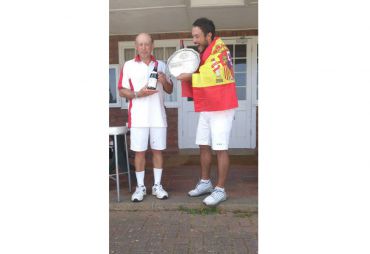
[195,109,235,150]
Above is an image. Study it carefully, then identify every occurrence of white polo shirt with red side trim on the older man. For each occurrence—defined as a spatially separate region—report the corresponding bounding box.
[118,56,170,128]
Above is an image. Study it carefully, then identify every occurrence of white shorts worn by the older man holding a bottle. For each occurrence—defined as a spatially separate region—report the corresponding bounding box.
[130,127,167,152]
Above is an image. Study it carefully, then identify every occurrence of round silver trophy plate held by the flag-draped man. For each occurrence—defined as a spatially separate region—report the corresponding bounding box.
[167,48,200,77]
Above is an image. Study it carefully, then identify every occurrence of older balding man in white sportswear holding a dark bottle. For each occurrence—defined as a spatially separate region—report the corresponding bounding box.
[118,33,173,202]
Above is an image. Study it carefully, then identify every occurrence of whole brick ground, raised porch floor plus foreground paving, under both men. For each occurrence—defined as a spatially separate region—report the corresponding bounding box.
[109,155,258,254]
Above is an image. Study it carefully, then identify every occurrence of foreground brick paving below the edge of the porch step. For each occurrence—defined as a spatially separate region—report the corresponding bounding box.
[109,210,258,254]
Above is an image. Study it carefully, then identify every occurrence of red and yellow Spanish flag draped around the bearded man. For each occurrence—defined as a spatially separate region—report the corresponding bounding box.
[182,37,238,112]
